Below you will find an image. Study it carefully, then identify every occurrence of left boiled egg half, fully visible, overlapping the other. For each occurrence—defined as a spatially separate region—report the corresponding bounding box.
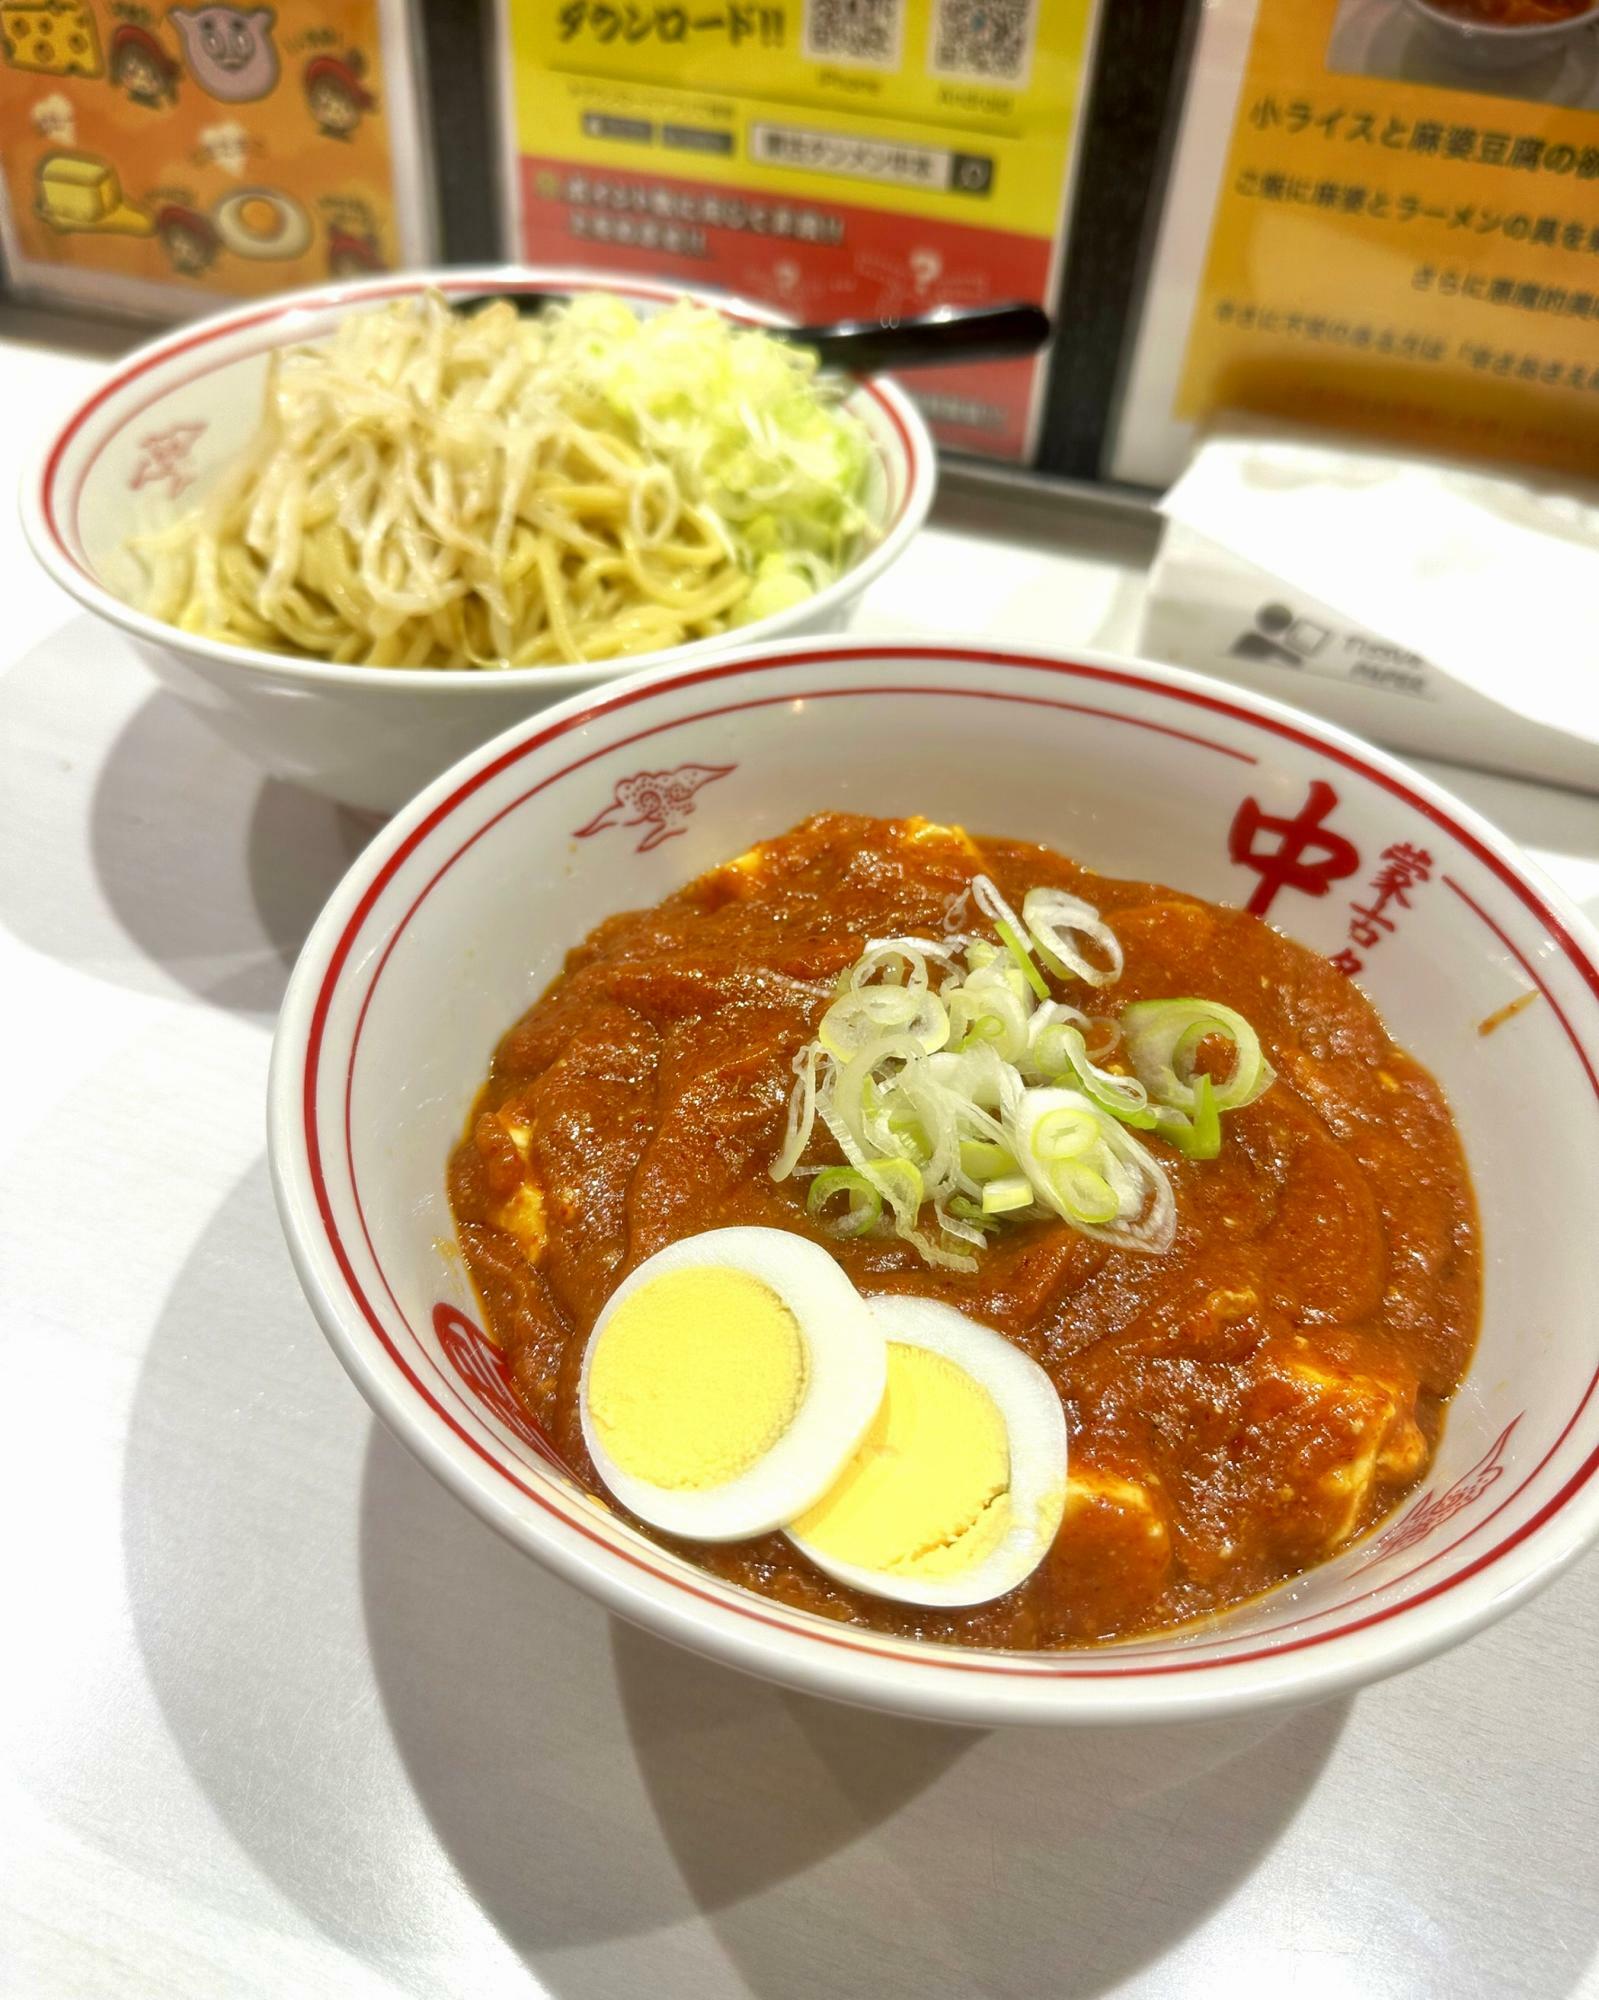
[578,1228,887,1542]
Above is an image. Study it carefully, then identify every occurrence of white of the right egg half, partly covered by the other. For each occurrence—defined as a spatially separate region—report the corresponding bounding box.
[788,1296,1065,1608]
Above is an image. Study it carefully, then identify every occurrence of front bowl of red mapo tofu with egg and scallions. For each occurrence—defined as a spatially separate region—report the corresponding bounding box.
[272,642,1599,1722]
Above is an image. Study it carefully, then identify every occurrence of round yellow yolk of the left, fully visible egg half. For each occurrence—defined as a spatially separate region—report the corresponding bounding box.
[588,1264,807,1492]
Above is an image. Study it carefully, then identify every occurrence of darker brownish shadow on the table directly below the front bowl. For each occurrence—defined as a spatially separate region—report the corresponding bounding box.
[362,1408,1349,1996]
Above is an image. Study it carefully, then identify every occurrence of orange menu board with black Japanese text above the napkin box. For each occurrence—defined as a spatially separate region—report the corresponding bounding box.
[1107,0,1599,484]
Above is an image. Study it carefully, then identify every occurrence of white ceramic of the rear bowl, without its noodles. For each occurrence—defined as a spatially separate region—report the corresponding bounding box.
[22,266,937,812]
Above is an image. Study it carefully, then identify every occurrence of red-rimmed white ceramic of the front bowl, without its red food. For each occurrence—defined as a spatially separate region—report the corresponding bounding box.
[270,640,1599,1724]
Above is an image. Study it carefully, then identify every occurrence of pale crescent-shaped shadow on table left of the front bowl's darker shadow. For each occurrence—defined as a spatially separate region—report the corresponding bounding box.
[122,1158,443,1964]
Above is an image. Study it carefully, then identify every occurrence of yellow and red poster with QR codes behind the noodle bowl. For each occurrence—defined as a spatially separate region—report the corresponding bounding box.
[502,0,1095,462]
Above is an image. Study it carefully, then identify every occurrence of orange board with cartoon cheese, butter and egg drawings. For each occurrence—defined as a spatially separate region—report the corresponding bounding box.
[0,0,432,314]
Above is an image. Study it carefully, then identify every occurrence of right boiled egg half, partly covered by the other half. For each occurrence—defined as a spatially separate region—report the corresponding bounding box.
[788,1296,1065,1606]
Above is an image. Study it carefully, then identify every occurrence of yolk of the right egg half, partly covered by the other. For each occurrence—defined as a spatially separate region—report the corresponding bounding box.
[794,1340,1011,1578]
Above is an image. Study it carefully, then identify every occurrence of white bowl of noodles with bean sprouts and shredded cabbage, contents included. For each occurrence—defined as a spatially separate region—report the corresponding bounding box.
[22,268,935,812]
